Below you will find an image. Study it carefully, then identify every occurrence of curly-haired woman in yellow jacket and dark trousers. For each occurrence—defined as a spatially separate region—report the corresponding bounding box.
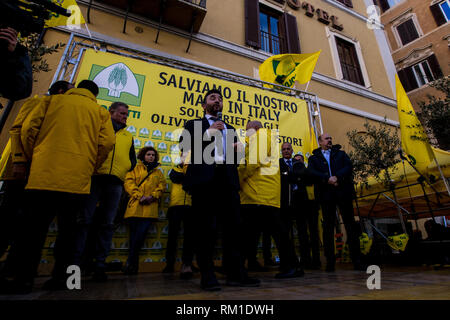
[124,147,166,274]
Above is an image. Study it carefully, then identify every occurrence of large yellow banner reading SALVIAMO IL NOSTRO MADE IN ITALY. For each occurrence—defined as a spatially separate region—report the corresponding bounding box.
[77,50,311,174]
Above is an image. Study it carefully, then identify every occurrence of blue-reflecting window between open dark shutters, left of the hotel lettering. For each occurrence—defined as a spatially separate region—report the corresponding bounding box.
[259,9,285,54]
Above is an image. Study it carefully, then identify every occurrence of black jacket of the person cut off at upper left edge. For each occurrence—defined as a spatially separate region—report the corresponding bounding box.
[0,44,33,101]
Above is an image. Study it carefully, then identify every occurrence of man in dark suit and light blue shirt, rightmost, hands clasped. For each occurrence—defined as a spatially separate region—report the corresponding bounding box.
[308,133,365,272]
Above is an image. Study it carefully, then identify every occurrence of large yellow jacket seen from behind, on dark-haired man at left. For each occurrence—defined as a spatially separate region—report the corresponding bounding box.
[21,88,115,194]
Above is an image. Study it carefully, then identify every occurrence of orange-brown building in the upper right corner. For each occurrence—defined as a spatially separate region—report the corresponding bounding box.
[377,0,450,109]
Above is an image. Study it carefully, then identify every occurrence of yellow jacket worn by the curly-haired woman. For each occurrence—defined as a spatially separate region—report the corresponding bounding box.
[124,161,166,218]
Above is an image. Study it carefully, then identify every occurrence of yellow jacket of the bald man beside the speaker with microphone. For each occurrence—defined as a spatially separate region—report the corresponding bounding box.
[238,128,281,208]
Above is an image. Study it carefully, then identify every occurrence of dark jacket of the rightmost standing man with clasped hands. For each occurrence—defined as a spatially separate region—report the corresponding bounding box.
[308,144,354,201]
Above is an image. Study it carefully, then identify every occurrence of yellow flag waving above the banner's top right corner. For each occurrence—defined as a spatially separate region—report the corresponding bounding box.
[259,50,322,88]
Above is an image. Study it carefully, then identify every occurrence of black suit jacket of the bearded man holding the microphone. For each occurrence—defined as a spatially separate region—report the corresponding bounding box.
[180,117,240,192]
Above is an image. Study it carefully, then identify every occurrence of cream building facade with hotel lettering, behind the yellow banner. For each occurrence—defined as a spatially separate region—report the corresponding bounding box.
[2,0,398,151]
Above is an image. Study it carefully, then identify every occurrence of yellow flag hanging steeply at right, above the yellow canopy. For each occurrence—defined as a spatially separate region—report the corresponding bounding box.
[395,75,434,173]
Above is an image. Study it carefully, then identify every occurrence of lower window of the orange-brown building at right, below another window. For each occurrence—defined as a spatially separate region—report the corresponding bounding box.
[398,54,443,92]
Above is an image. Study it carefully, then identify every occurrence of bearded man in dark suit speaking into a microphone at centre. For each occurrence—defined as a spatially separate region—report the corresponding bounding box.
[180,89,260,291]
